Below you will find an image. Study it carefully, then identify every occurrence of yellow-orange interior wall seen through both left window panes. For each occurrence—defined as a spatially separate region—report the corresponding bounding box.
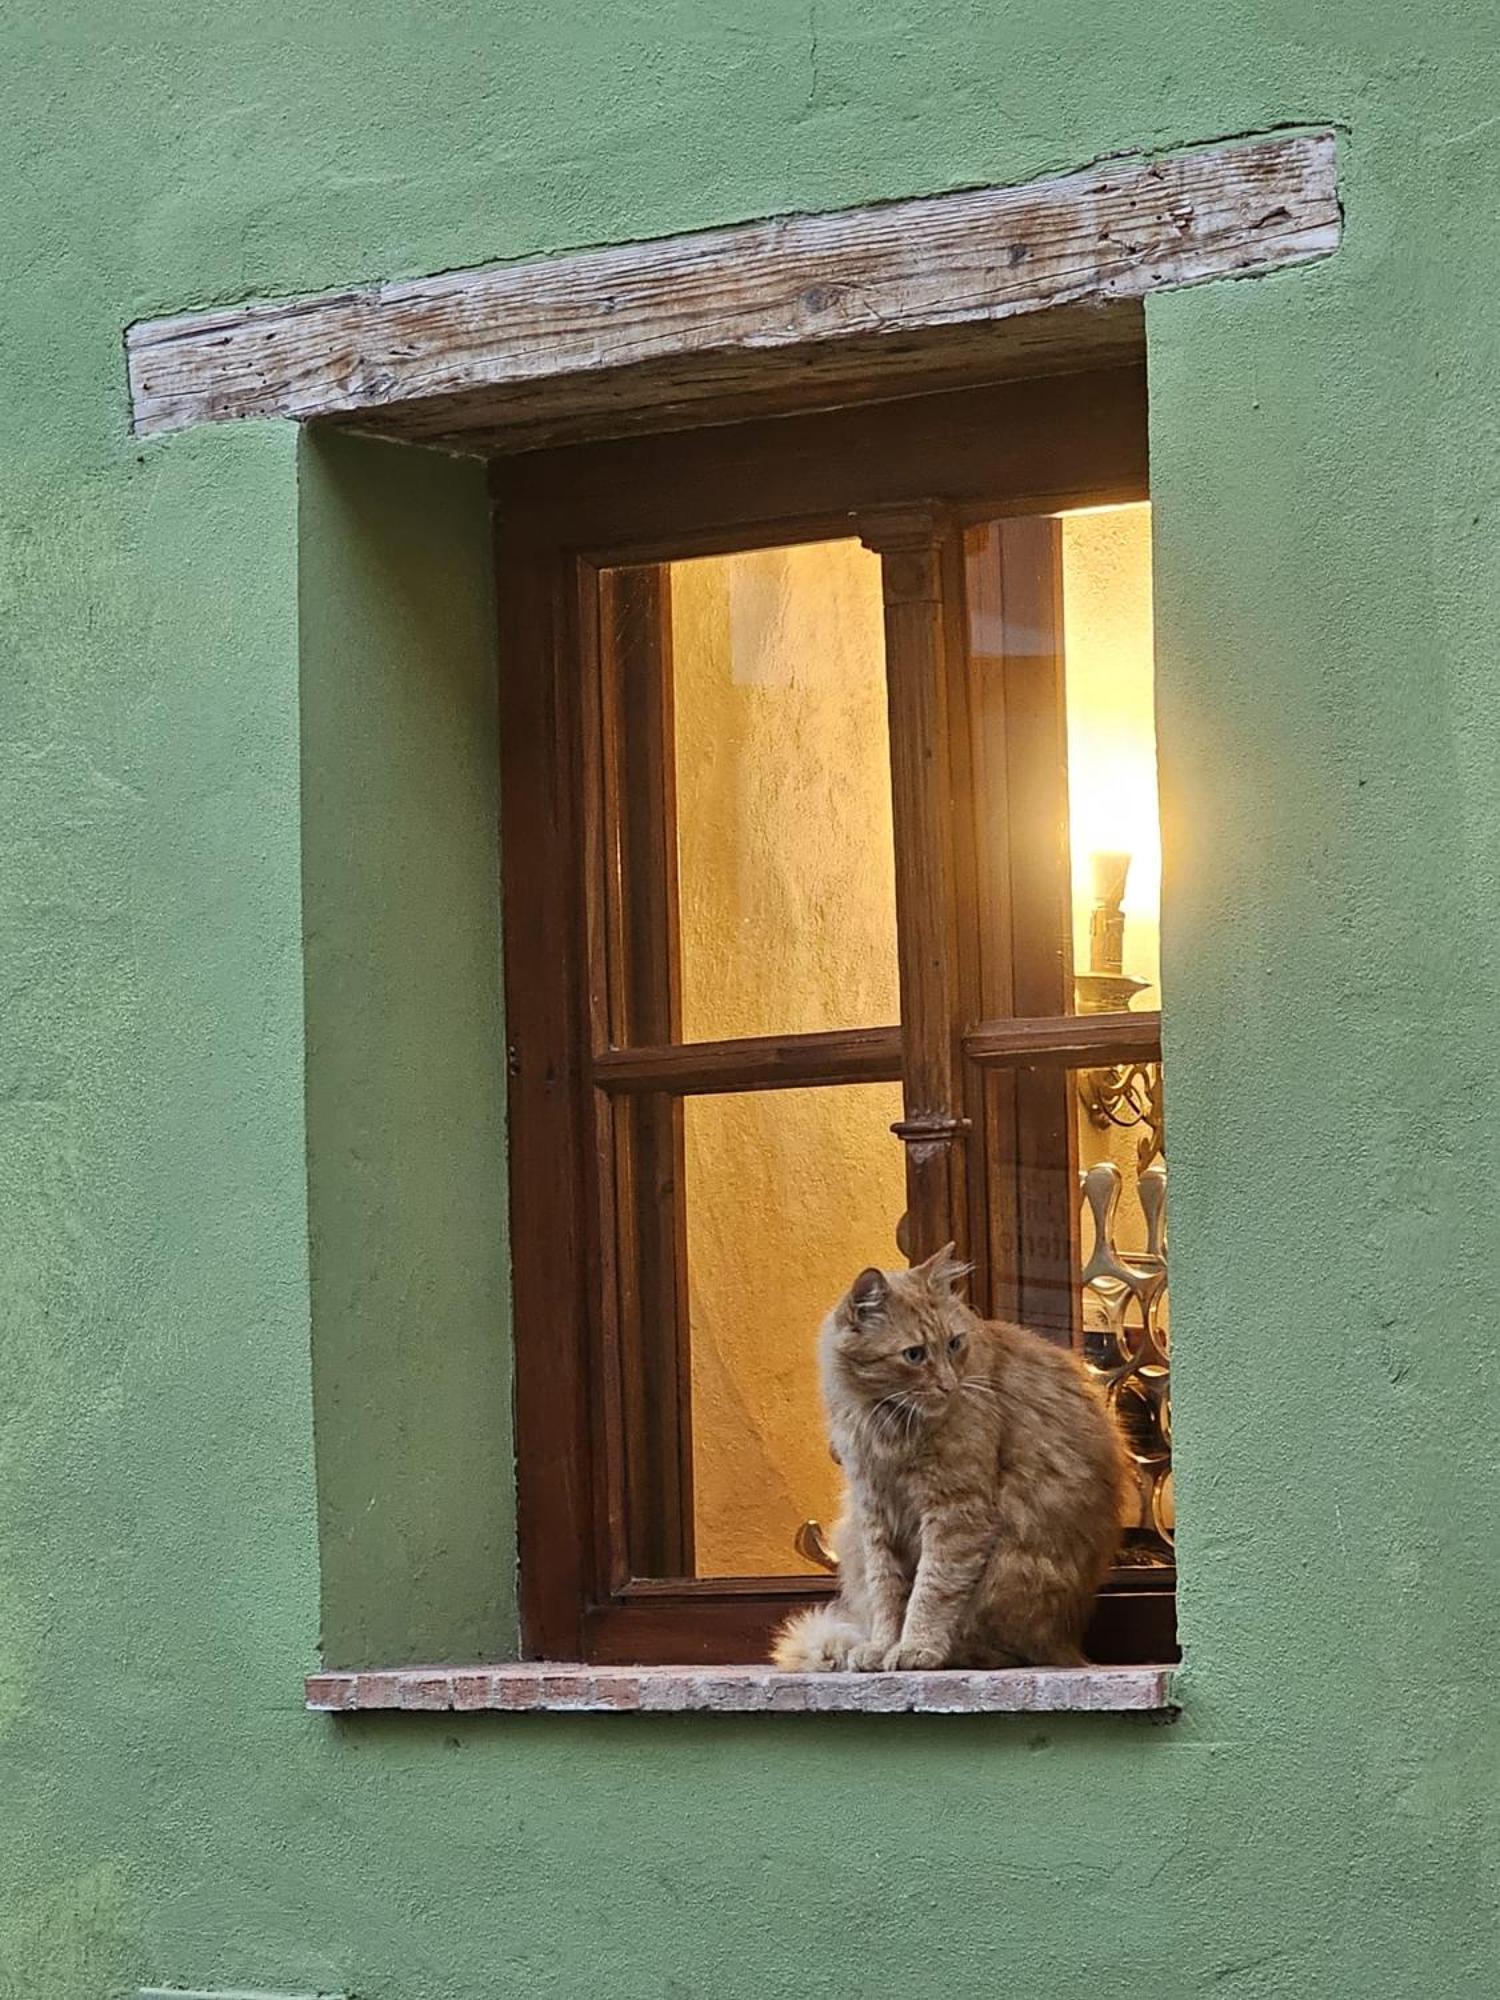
[672,542,906,1576]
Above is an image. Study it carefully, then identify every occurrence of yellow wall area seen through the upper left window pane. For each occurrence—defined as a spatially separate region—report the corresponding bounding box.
[668,540,900,1042]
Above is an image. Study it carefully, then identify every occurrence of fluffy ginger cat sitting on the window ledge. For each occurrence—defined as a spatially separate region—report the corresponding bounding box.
[774,1244,1126,1672]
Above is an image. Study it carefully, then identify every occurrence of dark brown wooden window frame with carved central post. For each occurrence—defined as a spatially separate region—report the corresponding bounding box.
[492,366,1174,1662]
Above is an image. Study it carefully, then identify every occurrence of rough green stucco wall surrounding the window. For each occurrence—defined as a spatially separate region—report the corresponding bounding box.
[0,0,1500,2000]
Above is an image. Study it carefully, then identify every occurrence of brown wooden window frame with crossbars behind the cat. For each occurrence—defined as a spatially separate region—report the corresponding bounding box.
[492,368,1172,1662]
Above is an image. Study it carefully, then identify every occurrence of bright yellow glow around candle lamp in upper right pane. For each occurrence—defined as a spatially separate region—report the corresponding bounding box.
[1062,504,1162,1006]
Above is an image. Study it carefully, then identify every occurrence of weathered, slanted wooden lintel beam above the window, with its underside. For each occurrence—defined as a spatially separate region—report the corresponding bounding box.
[126,132,1340,452]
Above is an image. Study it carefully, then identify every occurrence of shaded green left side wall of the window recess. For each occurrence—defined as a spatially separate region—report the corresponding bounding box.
[298,434,516,1666]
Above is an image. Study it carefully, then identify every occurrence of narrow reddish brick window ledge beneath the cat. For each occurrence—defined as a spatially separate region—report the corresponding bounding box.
[306,1660,1174,1716]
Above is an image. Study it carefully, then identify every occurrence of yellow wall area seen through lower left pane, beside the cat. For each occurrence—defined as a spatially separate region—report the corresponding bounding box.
[684,1084,906,1576]
